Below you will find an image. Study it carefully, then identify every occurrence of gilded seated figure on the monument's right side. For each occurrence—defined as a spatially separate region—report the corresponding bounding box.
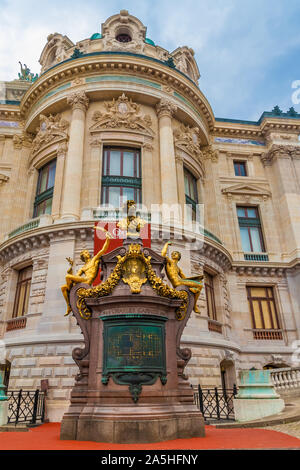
[161,241,203,313]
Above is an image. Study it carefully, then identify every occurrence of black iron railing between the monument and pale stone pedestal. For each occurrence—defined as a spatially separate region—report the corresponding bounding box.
[194,385,237,420]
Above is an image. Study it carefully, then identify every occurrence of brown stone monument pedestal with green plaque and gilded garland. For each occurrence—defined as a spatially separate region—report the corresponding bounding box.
[61,244,204,443]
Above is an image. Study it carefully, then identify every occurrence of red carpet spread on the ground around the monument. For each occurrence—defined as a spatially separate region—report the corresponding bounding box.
[0,423,300,450]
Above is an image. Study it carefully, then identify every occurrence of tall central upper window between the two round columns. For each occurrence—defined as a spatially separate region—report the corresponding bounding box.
[101,147,142,207]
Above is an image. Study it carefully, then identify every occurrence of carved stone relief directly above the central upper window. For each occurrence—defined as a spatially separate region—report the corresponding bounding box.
[90,93,153,137]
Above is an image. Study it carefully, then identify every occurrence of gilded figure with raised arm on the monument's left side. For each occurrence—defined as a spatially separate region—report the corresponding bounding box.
[61,227,112,315]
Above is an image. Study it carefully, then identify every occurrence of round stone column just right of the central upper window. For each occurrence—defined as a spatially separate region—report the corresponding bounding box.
[156,98,179,223]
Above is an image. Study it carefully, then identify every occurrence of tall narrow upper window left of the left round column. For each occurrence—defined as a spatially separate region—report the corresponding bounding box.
[33,160,56,217]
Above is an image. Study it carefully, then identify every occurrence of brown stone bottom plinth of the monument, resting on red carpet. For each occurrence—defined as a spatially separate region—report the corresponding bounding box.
[60,412,205,444]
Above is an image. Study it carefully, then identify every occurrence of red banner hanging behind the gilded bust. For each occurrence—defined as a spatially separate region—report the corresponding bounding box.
[93,221,151,286]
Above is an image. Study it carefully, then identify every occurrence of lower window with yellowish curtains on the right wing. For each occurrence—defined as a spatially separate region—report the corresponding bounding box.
[247,287,281,339]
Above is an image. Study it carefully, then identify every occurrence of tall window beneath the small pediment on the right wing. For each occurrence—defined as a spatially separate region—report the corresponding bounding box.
[237,207,265,253]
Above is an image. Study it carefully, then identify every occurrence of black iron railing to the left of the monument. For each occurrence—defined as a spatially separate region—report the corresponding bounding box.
[7,390,45,424]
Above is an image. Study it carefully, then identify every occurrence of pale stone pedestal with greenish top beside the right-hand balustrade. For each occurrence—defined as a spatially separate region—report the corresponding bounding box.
[234,370,284,422]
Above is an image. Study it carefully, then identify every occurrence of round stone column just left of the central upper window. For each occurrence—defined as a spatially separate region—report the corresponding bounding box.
[61,91,89,220]
